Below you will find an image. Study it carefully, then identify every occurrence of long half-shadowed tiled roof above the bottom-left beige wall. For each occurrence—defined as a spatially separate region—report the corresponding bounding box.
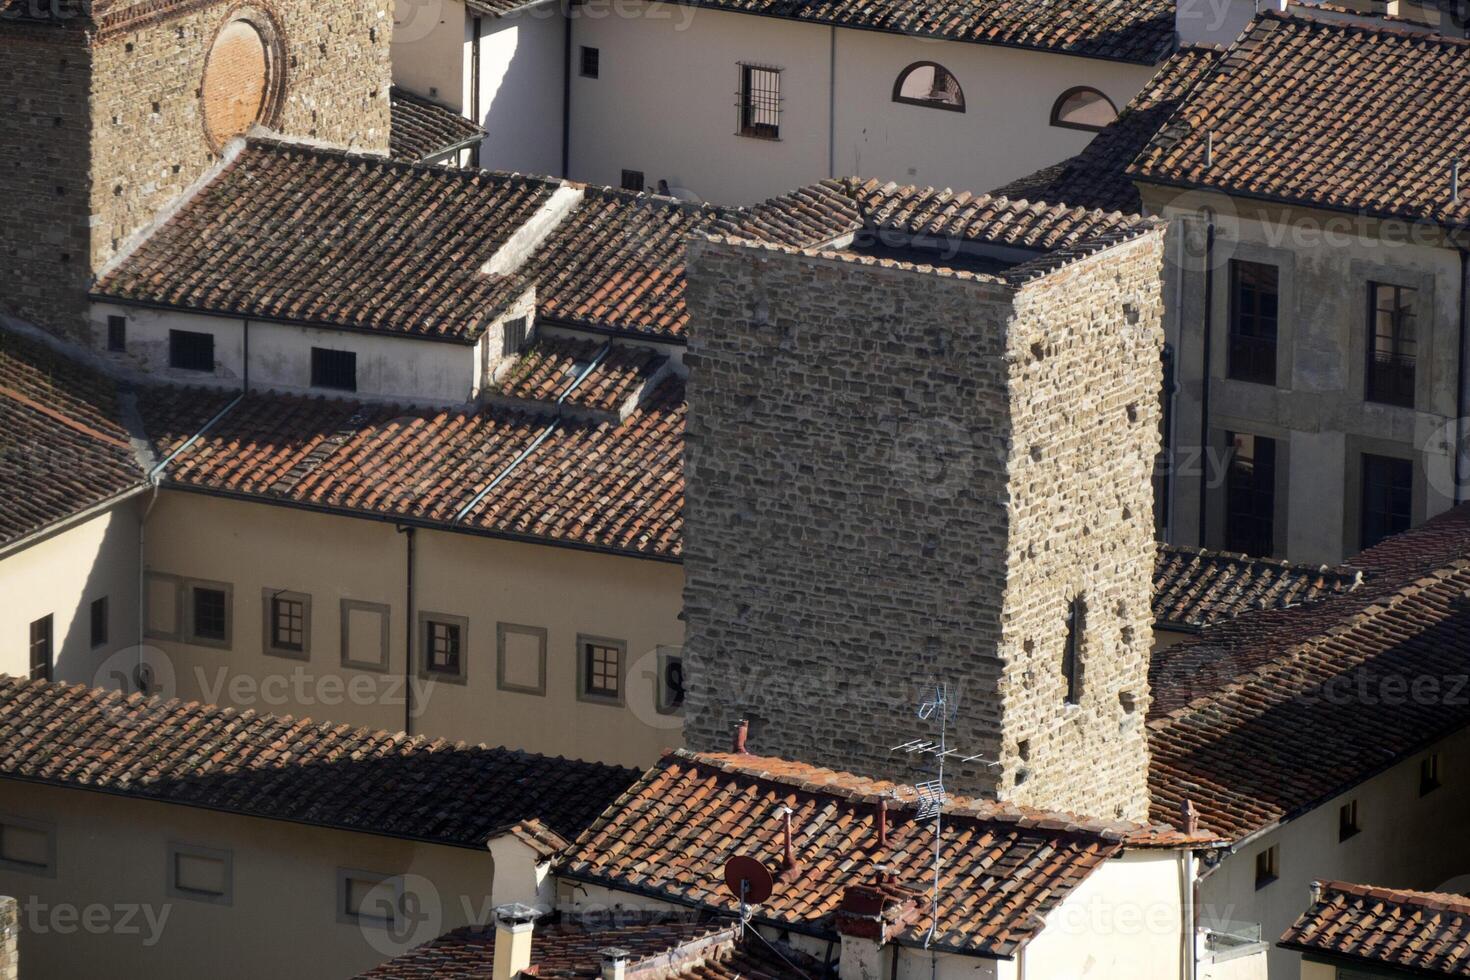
[0,676,637,848]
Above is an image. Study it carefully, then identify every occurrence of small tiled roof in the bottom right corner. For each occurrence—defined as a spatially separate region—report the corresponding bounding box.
[1280,882,1470,977]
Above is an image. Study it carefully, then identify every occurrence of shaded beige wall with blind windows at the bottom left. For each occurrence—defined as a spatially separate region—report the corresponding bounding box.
[0,780,494,980]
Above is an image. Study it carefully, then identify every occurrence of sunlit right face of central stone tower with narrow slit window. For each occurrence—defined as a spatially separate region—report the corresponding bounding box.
[1001,232,1163,820]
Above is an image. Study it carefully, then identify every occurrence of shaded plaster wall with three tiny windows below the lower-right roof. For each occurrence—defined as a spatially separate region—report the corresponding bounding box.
[1200,725,1470,980]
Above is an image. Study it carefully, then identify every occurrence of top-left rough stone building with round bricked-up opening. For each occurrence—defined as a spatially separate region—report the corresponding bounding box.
[0,0,392,339]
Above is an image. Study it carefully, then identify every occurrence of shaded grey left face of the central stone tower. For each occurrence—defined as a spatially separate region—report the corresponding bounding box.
[684,241,1010,792]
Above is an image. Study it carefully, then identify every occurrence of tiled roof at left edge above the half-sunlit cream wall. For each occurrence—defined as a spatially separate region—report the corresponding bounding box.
[0,331,146,545]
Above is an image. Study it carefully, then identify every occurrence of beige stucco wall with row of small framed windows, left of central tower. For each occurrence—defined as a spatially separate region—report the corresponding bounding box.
[138,491,684,765]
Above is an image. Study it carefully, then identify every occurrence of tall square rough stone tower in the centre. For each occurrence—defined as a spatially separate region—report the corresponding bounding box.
[685,229,1163,818]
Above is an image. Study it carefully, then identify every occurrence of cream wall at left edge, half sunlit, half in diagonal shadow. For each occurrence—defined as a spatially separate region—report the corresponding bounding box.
[0,497,140,683]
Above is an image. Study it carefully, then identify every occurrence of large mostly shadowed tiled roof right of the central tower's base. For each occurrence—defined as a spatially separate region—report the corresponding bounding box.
[1150,505,1470,840]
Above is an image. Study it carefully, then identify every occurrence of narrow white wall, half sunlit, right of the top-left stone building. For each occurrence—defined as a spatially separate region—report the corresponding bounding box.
[466,3,564,174]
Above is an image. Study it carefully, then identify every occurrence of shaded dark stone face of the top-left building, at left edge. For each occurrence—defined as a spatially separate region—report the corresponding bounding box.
[0,19,91,337]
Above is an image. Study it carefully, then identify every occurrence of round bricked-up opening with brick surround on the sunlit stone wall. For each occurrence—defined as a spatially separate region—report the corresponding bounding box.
[200,7,285,153]
